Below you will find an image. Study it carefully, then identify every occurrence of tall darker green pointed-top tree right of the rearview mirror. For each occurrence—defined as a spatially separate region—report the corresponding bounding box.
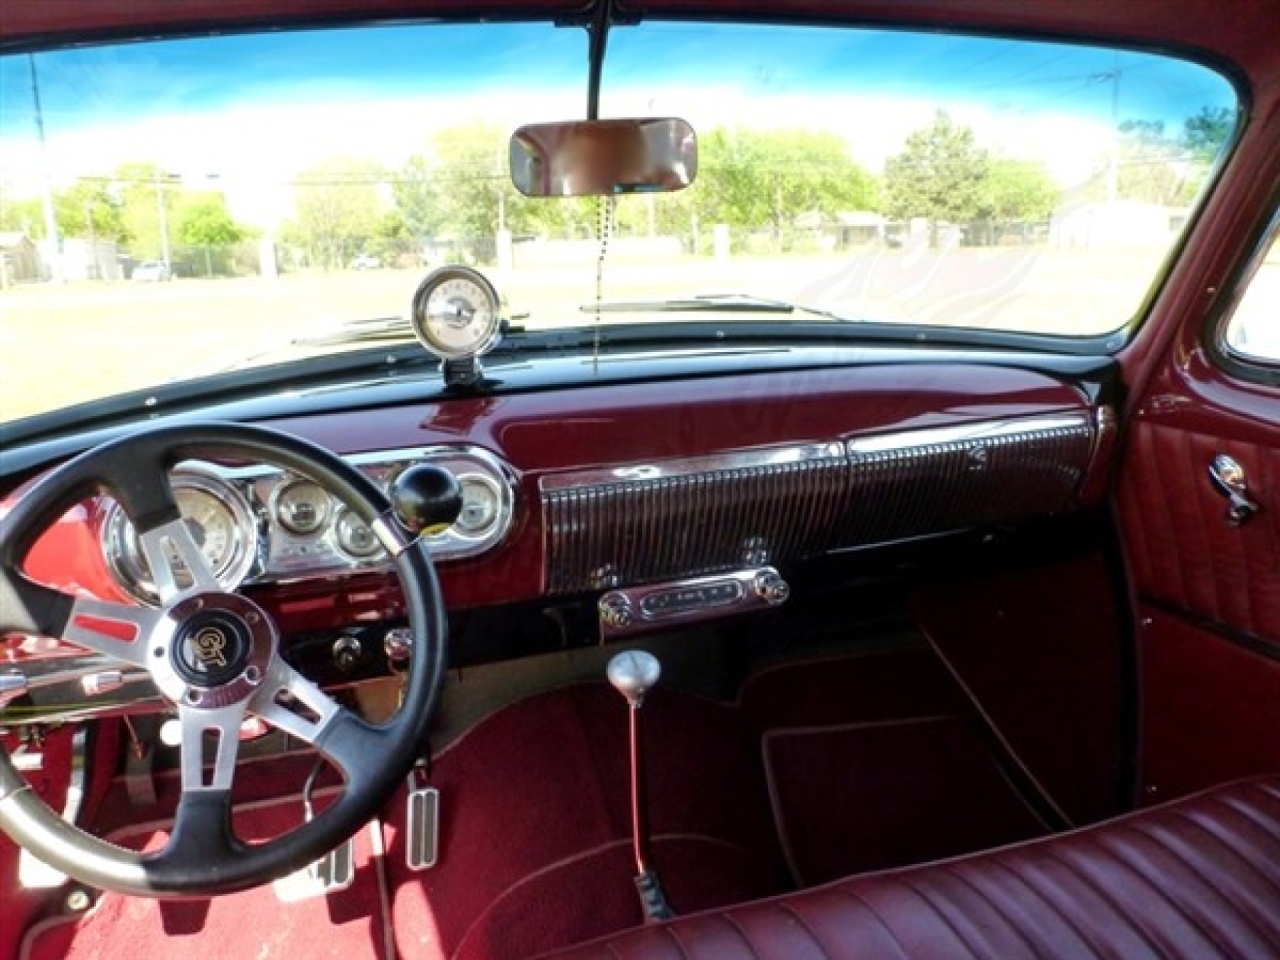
[884,110,991,246]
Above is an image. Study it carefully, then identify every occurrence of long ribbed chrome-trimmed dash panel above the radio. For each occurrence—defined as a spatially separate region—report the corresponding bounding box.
[540,412,1096,594]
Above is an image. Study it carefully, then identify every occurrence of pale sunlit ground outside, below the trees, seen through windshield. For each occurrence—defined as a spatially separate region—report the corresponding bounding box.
[0,247,1239,422]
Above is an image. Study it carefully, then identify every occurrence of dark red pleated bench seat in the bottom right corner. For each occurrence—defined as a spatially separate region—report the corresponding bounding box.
[554,777,1280,960]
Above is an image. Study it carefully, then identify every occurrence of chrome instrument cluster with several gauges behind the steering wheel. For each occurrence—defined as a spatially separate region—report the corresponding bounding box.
[99,445,516,603]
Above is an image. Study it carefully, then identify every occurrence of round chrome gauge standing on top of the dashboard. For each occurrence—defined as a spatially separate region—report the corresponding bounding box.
[412,266,499,360]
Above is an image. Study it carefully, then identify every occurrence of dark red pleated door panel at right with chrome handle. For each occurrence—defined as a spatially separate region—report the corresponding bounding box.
[1116,329,1280,803]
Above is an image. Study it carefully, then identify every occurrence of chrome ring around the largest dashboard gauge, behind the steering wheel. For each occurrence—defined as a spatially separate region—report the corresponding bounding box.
[99,465,259,605]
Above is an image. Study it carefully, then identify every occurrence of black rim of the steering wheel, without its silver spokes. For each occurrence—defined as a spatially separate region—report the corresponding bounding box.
[0,422,445,897]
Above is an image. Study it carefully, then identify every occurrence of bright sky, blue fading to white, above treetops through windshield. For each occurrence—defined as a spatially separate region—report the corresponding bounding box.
[0,22,1235,229]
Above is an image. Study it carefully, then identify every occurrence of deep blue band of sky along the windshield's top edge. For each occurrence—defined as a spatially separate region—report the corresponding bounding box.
[0,23,1231,134]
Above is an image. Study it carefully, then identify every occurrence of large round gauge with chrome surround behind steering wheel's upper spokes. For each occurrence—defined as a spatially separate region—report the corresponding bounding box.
[101,466,259,604]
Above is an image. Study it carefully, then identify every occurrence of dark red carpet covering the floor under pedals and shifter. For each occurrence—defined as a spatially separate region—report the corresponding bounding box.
[27,649,1039,960]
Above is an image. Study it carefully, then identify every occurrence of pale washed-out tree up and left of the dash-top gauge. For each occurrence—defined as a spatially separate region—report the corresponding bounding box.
[285,159,387,270]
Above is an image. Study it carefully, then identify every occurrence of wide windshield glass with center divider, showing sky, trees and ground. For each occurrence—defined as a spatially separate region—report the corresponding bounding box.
[0,22,1238,421]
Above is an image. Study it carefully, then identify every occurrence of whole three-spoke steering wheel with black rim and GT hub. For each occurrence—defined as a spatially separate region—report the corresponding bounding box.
[0,424,445,897]
